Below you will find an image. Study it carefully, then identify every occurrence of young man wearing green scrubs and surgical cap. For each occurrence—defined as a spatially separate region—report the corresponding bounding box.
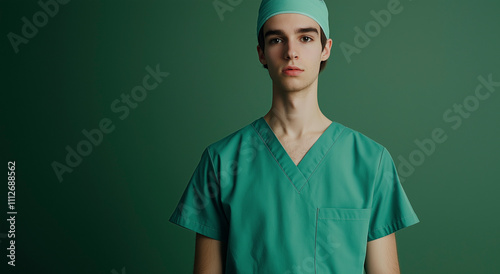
[170,0,419,274]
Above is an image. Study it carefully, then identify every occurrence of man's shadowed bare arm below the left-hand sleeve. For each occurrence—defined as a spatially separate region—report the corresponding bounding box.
[193,233,227,274]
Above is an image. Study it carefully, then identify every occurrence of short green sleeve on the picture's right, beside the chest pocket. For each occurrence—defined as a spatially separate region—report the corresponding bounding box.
[368,148,420,241]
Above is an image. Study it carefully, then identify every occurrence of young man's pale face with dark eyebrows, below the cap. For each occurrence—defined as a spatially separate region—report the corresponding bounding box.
[257,13,331,91]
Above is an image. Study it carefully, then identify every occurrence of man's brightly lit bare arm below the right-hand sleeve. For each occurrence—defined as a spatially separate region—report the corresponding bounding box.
[365,233,400,274]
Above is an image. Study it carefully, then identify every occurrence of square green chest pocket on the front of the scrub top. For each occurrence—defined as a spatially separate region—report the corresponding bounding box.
[314,208,371,274]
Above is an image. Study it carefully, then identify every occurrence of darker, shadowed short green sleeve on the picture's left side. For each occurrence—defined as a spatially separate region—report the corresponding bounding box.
[169,147,229,242]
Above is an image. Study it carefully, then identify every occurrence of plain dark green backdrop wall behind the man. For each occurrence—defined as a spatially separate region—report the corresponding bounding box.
[0,0,500,274]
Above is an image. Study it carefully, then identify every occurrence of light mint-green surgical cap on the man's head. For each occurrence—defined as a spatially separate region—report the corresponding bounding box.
[257,0,330,39]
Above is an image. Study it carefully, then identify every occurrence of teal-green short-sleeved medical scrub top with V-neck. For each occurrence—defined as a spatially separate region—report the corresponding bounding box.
[169,117,419,274]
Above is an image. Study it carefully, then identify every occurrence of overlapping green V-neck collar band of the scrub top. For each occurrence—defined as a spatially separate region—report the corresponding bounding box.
[252,117,345,193]
